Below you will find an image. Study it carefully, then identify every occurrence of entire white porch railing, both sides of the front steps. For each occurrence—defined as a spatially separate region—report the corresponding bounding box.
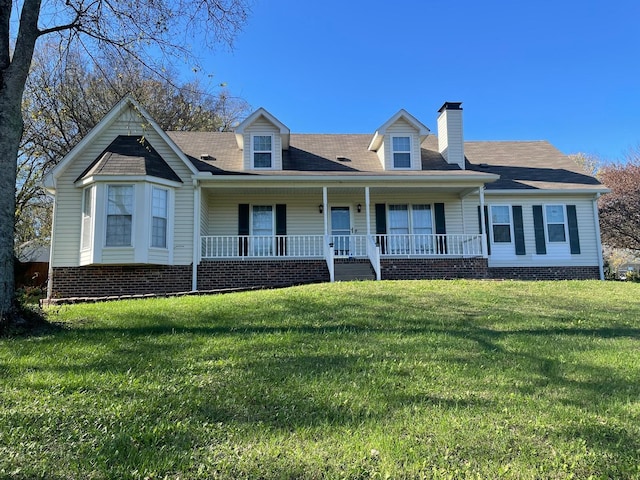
[201,234,482,258]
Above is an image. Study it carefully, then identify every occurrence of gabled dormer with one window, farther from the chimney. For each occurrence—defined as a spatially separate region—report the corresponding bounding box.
[235,108,291,170]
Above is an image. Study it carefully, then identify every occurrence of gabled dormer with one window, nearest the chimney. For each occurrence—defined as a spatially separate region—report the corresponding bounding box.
[369,109,429,171]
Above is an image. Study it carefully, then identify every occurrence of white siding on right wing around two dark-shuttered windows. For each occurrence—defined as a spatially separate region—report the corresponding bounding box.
[465,193,600,267]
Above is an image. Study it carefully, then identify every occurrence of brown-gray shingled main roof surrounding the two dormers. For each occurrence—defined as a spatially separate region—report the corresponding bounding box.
[162,132,602,190]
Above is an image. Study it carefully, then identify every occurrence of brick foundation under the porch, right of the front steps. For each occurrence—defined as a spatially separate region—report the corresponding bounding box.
[380,258,487,280]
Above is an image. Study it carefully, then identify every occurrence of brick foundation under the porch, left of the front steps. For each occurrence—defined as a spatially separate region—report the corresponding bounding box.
[198,260,329,290]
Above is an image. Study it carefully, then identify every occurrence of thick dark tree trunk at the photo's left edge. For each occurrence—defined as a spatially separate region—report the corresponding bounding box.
[0,0,41,325]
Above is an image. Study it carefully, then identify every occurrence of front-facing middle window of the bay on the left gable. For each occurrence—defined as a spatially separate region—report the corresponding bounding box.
[105,185,133,247]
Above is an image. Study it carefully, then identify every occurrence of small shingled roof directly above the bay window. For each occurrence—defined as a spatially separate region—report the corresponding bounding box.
[76,135,182,183]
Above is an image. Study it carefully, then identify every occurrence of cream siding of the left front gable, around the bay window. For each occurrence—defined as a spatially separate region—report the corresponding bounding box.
[51,104,193,267]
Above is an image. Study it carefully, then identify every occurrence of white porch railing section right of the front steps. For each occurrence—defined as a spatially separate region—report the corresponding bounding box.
[377,234,482,257]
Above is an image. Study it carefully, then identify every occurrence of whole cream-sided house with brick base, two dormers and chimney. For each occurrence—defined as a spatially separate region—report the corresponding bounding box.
[45,96,606,297]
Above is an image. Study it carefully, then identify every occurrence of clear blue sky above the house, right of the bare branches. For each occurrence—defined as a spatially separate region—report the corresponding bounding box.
[198,0,640,160]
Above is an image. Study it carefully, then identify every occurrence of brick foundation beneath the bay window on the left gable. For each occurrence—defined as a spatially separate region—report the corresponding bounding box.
[52,265,191,298]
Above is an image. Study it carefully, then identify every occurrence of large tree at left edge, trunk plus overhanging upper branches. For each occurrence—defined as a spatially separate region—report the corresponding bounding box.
[0,0,249,325]
